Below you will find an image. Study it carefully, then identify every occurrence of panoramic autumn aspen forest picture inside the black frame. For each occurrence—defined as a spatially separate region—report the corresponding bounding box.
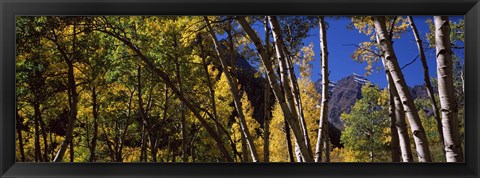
[16,16,465,162]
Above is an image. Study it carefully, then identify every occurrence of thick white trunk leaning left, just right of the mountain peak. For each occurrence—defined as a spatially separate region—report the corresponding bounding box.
[374,16,432,162]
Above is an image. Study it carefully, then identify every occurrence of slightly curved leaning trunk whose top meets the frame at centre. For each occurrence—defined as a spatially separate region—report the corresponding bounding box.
[236,16,313,162]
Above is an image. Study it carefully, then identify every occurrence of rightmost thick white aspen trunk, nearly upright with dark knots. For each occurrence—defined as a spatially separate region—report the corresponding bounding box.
[433,16,463,162]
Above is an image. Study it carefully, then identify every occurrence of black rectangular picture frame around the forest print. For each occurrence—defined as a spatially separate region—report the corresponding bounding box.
[0,0,480,178]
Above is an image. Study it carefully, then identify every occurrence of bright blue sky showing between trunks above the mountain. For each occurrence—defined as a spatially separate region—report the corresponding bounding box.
[304,16,463,88]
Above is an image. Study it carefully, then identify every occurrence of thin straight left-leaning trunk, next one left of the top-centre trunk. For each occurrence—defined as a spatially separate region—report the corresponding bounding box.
[204,17,259,162]
